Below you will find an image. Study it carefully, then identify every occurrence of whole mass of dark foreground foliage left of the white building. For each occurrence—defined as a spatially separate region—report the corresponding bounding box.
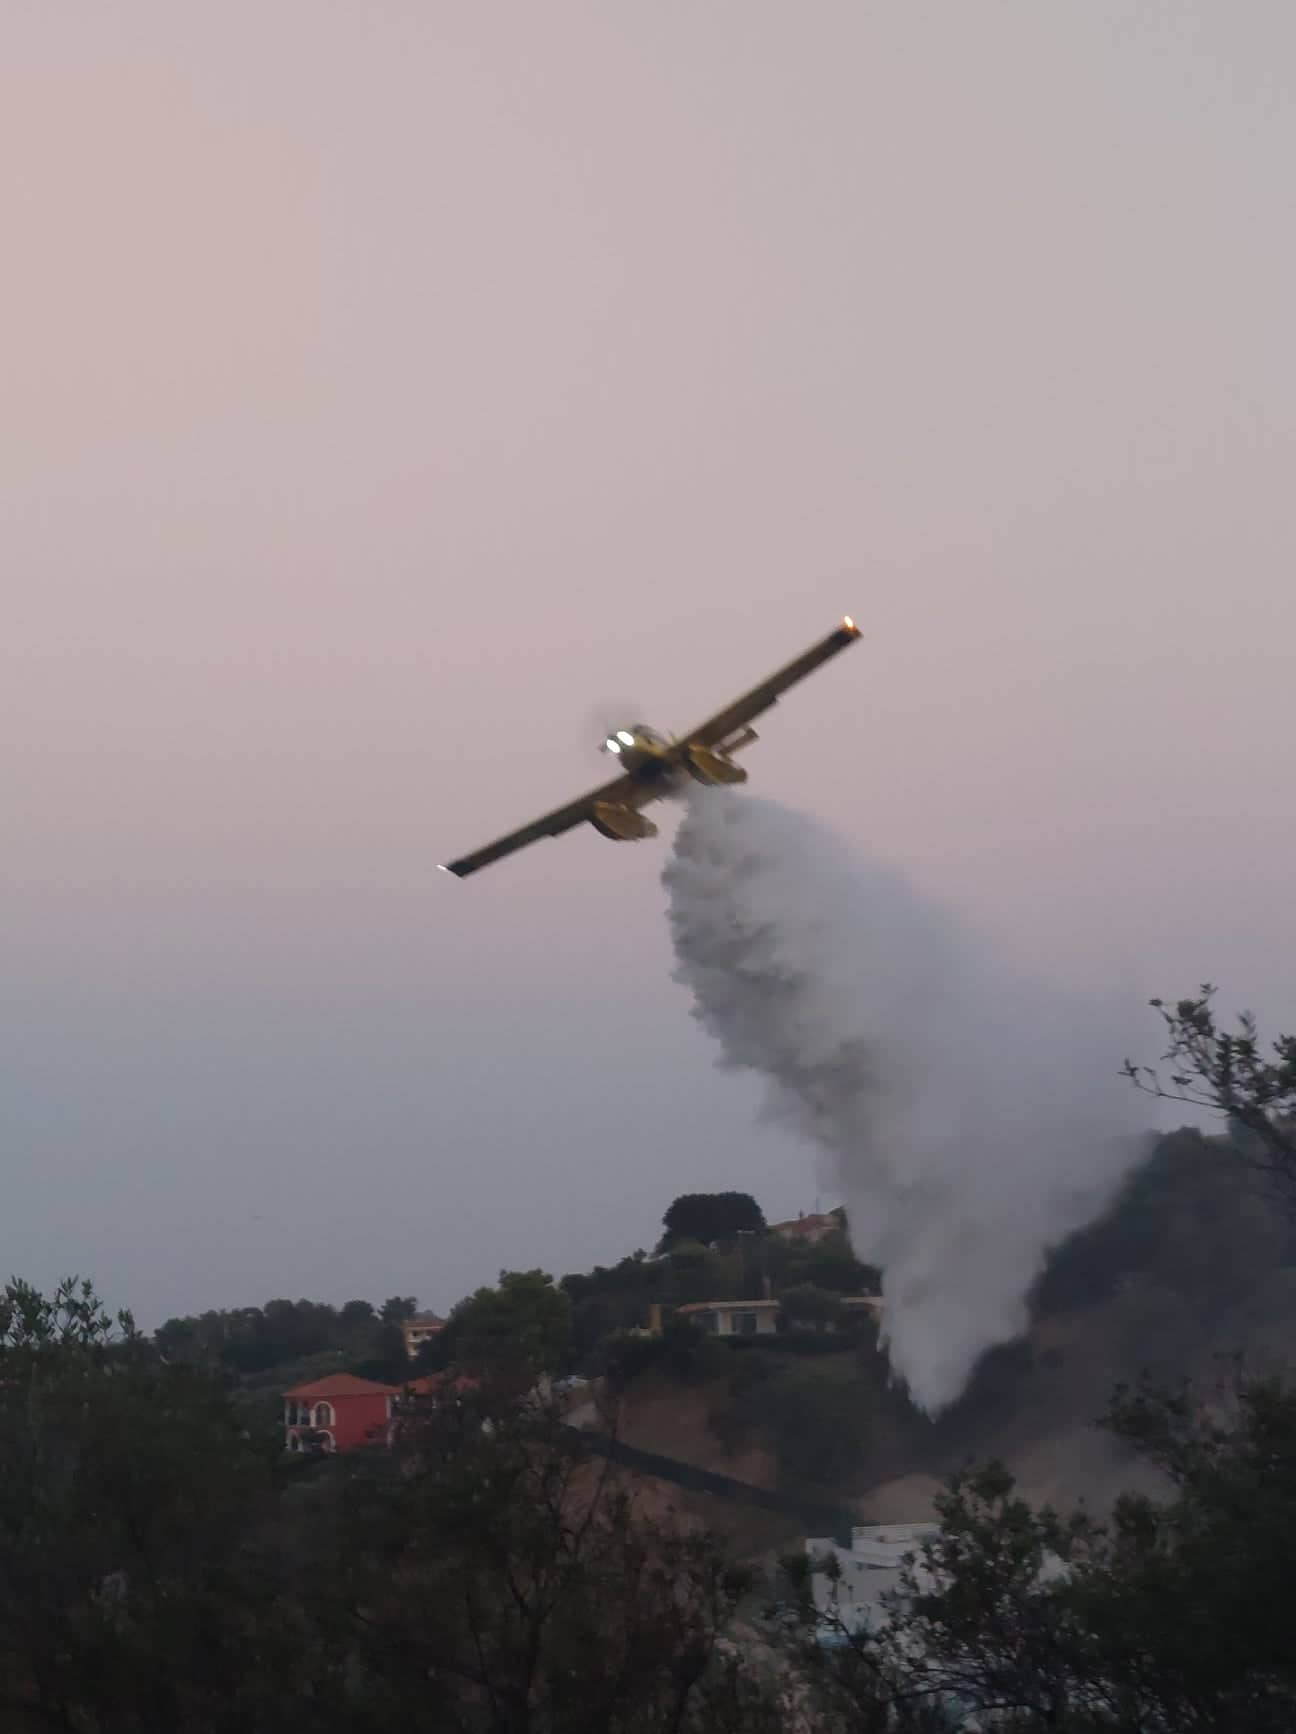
[0,1283,781,1734]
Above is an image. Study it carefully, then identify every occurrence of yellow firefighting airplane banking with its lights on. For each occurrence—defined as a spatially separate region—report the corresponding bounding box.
[441,614,859,879]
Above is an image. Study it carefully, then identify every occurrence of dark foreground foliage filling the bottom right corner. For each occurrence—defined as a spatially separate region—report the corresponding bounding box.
[802,1380,1296,1734]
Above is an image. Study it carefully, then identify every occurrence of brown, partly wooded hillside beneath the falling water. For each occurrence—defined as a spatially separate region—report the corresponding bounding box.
[596,1131,1296,1521]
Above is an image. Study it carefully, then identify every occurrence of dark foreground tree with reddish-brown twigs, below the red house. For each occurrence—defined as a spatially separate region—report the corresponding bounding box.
[315,1380,786,1734]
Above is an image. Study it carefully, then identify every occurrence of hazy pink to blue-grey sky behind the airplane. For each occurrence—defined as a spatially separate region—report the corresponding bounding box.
[0,0,1296,1323]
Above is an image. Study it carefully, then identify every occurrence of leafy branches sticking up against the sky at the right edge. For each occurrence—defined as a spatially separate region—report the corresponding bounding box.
[1124,981,1296,1193]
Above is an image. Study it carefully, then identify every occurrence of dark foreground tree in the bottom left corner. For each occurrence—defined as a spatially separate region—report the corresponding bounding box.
[0,1281,322,1734]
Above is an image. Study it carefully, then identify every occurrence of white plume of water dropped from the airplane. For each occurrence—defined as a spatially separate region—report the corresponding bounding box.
[663,791,1135,1413]
